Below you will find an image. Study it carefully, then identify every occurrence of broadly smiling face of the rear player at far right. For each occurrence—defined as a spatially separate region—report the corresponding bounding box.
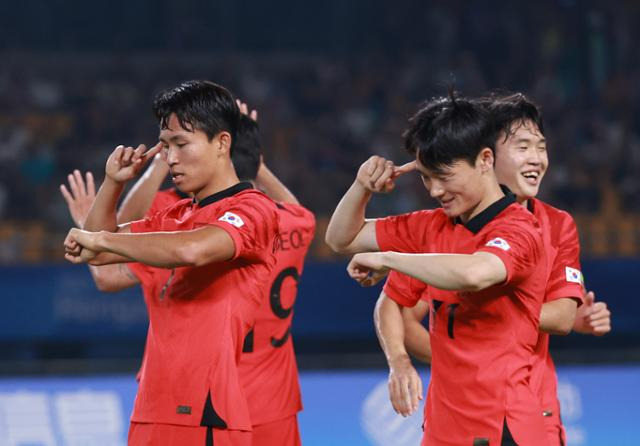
[496,121,549,202]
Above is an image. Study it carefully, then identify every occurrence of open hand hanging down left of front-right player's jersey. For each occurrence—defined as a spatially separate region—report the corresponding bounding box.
[389,355,422,417]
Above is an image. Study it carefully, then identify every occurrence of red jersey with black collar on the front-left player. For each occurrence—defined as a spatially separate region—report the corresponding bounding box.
[131,183,278,430]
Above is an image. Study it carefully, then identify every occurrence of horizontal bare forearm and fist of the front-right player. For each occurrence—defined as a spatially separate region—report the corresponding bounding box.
[347,252,507,291]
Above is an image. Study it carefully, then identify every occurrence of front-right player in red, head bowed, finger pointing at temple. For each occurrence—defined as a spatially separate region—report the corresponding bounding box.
[326,92,547,445]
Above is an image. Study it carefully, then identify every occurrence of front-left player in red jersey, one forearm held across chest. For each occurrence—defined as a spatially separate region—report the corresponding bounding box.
[65,81,278,445]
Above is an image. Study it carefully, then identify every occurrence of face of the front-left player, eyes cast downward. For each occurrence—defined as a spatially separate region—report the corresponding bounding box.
[160,114,237,199]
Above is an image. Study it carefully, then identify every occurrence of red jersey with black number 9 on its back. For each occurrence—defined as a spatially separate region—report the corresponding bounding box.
[239,203,315,426]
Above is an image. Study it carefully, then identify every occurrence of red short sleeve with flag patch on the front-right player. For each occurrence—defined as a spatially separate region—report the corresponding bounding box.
[476,218,545,283]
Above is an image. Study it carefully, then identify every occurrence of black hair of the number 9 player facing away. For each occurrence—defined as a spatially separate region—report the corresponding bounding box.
[231,115,262,181]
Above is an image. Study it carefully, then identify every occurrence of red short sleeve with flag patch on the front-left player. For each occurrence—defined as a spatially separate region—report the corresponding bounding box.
[194,193,279,260]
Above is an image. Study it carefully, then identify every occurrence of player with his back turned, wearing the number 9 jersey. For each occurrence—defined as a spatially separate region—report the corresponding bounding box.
[233,103,315,446]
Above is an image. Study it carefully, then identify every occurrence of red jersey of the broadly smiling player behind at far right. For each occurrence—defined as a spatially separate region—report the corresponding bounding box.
[528,199,583,445]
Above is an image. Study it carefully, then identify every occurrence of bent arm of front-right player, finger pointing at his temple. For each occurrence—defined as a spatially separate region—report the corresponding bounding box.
[325,156,415,254]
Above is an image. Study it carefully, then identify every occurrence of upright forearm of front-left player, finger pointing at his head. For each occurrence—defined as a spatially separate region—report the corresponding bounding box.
[84,144,161,232]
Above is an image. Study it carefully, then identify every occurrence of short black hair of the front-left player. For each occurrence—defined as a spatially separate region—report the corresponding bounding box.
[153,80,240,148]
